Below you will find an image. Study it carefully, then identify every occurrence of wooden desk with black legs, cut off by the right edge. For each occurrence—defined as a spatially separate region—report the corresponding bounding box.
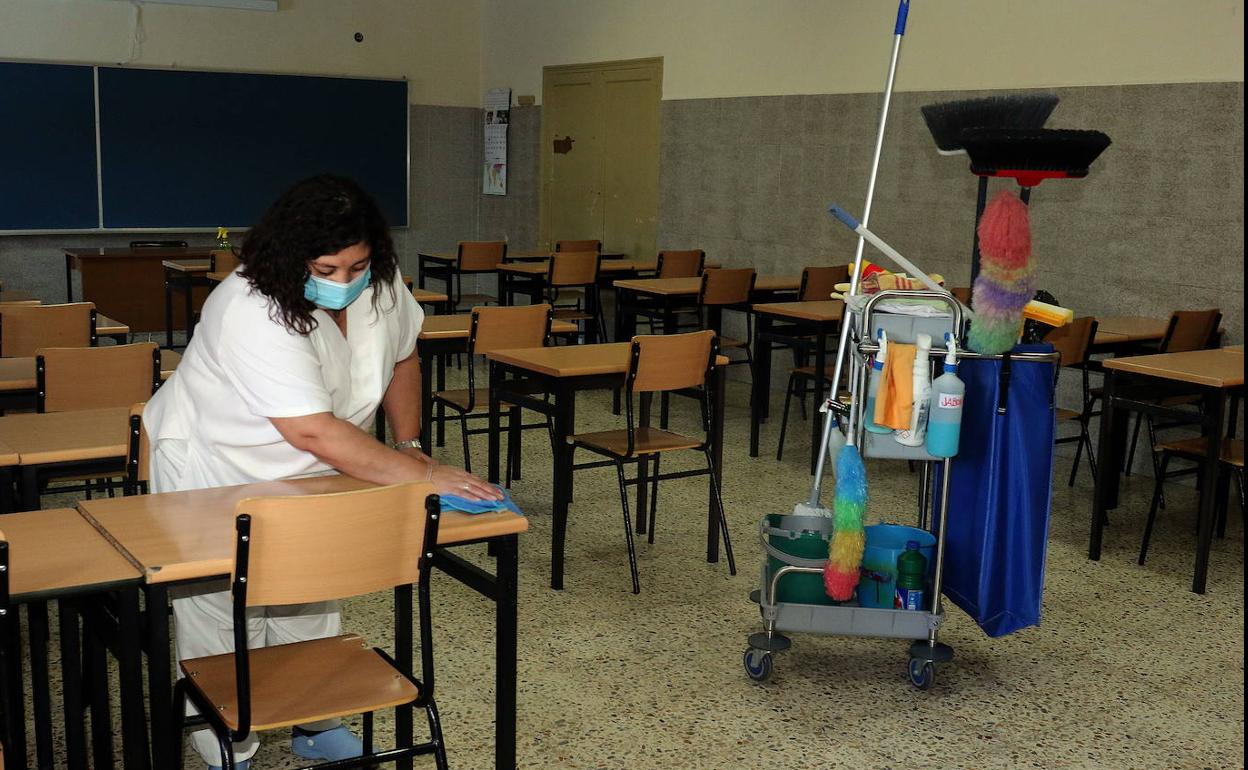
[1088,349,1244,594]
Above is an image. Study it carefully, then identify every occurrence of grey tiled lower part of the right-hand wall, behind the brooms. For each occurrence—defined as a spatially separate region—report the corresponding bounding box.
[659,82,1244,342]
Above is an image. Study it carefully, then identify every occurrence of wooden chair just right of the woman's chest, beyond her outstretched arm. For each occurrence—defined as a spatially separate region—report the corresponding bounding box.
[433,305,553,485]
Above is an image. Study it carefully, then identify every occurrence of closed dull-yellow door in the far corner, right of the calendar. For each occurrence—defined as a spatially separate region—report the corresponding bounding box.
[540,59,663,256]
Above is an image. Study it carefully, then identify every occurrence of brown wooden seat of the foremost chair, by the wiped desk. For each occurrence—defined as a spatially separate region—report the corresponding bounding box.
[181,634,419,730]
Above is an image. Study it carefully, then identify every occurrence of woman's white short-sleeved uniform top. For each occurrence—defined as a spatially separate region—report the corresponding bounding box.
[144,272,424,492]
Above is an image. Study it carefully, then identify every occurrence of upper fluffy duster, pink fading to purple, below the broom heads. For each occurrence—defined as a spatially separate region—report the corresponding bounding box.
[967,191,1036,354]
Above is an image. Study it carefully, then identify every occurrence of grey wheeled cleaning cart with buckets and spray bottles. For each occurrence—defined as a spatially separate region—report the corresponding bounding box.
[744,291,1056,690]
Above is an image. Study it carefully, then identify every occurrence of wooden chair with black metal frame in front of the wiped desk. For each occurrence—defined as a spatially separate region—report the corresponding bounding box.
[173,483,447,769]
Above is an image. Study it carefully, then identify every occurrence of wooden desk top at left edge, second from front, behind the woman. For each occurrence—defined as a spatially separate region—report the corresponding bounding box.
[0,407,130,465]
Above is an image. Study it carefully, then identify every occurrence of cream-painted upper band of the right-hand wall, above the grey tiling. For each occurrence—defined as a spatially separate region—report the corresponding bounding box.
[482,0,1244,101]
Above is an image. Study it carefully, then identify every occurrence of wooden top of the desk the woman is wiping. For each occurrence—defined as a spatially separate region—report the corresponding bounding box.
[78,475,529,583]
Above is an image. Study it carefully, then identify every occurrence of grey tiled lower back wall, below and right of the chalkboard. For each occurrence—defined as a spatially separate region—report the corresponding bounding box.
[0,105,481,302]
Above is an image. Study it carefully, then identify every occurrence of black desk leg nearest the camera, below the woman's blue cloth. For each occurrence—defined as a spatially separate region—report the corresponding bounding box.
[494,534,519,770]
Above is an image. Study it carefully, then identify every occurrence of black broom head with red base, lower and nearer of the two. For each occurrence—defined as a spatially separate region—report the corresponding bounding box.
[962,129,1109,187]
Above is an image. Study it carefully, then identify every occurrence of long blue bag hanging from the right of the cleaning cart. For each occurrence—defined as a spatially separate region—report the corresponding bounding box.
[932,343,1056,636]
